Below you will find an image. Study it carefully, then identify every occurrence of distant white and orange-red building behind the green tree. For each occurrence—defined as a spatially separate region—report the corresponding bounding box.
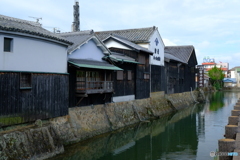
[202,57,229,77]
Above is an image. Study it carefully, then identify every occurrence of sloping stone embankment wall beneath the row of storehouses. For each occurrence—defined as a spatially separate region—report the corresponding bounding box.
[0,91,202,160]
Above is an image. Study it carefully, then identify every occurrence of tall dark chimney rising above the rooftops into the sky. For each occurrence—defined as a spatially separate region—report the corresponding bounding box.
[72,0,80,32]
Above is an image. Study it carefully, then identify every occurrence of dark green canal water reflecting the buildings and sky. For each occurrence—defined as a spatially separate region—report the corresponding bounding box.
[47,92,240,160]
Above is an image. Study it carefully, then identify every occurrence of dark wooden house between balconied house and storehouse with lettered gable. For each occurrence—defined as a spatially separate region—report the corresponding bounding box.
[103,35,153,101]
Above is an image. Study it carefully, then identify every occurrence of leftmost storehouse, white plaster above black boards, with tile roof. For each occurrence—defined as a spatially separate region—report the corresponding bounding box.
[0,15,72,127]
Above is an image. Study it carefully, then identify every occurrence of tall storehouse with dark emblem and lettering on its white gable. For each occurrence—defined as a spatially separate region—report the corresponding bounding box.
[96,26,166,92]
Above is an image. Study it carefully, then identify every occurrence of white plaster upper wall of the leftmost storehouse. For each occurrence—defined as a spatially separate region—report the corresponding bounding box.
[0,35,67,73]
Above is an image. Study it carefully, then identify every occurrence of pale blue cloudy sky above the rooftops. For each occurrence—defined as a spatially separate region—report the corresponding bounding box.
[0,0,240,69]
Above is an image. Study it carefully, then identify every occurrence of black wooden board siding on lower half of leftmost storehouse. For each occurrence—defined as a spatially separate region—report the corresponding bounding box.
[0,72,68,126]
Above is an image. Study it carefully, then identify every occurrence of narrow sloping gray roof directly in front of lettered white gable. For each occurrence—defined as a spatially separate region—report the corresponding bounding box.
[104,34,153,55]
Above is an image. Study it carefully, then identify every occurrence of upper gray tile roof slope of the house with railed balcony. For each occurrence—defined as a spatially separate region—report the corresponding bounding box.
[59,30,94,52]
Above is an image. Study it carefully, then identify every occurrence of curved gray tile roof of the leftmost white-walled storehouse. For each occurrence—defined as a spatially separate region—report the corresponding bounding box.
[0,15,72,44]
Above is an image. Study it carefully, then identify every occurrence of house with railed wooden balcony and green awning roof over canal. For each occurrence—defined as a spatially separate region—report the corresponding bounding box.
[60,31,122,107]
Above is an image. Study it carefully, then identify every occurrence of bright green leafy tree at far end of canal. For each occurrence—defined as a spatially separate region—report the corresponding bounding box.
[208,66,224,90]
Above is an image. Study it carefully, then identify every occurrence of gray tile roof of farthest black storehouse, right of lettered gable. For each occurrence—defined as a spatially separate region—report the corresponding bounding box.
[164,45,195,63]
